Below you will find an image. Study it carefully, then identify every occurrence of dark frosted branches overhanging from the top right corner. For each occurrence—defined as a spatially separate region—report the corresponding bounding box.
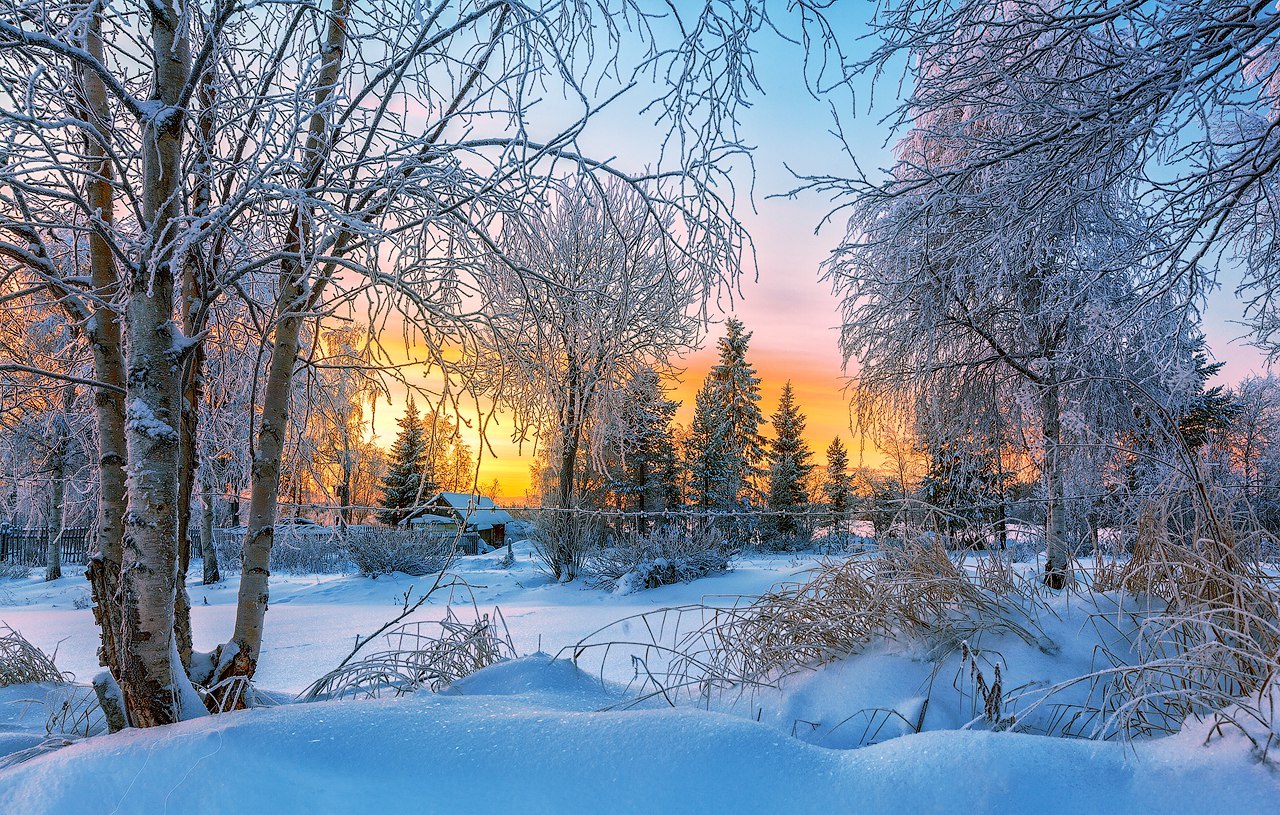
[829,0,1280,351]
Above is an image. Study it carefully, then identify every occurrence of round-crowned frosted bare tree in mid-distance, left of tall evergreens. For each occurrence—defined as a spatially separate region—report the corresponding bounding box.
[483,177,733,577]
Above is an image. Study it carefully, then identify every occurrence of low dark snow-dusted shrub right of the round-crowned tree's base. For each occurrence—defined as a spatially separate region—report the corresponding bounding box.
[585,525,737,594]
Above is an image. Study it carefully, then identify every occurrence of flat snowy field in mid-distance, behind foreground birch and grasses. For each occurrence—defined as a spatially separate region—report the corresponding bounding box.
[0,545,818,693]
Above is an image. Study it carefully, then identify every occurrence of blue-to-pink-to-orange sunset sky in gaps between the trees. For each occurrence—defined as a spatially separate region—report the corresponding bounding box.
[375,4,1265,503]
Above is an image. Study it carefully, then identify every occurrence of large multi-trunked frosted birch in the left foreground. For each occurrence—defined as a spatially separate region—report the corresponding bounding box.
[0,0,767,725]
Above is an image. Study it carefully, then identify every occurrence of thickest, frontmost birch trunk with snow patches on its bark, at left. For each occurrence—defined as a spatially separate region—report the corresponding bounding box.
[119,3,202,727]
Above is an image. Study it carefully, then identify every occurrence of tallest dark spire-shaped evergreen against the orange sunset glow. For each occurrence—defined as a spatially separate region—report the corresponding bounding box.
[703,317,767,504]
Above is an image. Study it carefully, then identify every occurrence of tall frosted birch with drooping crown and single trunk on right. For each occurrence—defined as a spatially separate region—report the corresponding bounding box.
[827,19,1185,587]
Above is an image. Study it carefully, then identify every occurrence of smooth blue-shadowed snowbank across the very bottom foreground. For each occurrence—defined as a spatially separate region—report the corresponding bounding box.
[0,655,1280,815]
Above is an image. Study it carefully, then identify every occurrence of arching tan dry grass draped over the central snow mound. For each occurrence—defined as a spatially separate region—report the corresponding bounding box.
[572,544,1059,704]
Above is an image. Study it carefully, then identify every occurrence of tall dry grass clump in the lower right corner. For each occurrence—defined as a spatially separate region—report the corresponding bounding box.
[1033,490,1280,740]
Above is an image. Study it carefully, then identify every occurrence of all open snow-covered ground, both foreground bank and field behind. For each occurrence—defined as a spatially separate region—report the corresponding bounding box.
[0,539,1280,815]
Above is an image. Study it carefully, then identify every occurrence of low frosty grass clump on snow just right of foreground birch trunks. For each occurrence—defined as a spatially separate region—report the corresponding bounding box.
[298,606,516,701]
